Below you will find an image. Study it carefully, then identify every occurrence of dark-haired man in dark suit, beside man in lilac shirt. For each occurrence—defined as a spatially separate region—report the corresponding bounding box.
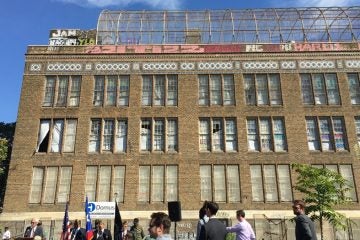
[200,202,227,240]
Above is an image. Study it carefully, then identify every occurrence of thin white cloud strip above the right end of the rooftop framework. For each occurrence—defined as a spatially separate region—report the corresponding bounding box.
[271,0,359,7]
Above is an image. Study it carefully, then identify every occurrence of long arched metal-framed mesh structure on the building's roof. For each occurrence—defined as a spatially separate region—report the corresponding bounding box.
[97,7,360,45]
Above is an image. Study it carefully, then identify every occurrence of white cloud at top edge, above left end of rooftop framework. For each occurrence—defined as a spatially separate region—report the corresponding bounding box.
[56,0,181,10]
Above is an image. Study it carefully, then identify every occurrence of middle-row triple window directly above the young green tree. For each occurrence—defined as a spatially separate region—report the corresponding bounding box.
[306,117,348,151]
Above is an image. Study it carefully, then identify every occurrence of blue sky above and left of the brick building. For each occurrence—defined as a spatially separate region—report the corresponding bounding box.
[0,0,360,123]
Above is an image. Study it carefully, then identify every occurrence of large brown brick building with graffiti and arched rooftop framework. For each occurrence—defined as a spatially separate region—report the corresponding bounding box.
[0,7,360,239]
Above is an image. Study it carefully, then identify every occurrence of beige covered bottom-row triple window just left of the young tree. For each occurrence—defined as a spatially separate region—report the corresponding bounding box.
[250,164,293,202]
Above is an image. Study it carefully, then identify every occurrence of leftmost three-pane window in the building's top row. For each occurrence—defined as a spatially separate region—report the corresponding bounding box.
[43,76,81,107]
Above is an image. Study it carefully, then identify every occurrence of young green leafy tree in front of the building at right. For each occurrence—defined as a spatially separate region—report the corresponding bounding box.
[292,163,352,240]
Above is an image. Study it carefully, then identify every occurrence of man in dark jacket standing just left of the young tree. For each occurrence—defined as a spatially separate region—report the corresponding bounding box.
[292,200,317,240]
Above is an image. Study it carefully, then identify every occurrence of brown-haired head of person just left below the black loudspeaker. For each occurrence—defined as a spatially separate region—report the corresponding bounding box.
[149,212,171,238]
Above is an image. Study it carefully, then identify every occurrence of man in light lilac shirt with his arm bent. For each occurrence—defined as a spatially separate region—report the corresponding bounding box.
[226,210,255,240]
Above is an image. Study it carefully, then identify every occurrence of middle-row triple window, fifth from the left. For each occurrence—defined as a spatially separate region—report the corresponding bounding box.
[247,117,287,152]
